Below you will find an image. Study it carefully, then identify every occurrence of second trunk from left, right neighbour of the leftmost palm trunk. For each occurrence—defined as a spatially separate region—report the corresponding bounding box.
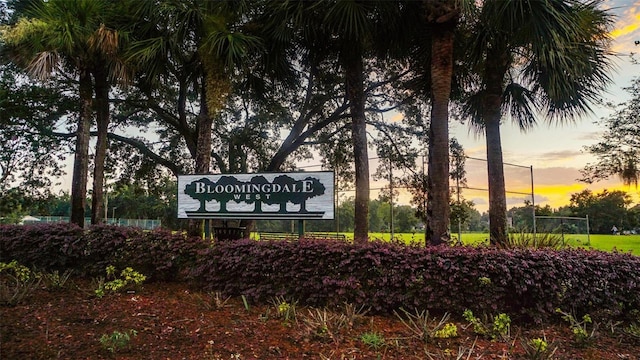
[91,69,109,225]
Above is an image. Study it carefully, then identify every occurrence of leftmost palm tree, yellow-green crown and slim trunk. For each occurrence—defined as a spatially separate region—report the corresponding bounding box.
[3,0,129,226]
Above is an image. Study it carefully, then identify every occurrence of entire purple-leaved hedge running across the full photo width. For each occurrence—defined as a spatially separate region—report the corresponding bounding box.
[0,224,640,320]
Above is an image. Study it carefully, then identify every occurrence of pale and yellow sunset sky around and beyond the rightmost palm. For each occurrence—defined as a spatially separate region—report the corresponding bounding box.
[440,0,640,211]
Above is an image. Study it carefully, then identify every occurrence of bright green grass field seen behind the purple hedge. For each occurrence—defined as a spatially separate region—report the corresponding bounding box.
[298,232,640,255]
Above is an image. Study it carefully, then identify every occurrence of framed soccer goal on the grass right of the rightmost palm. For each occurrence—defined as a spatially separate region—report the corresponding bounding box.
[535,215,591,246]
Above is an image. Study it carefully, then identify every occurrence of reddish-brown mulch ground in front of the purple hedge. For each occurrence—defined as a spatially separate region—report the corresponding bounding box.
[0,280,640,360]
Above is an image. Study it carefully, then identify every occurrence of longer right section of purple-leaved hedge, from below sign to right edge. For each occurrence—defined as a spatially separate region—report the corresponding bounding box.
[192,240,640,321]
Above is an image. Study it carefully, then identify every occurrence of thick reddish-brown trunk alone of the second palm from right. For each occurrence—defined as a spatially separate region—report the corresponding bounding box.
[426,24,454,245]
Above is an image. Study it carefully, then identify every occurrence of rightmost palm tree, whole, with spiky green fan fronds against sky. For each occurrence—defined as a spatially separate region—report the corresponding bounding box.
[467,0,611,244]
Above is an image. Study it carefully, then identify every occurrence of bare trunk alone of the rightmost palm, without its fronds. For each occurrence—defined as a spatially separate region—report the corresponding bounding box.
[482,45,509,245]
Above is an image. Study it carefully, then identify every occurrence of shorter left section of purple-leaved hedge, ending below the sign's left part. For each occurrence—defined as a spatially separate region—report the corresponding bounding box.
[0,223,207,281]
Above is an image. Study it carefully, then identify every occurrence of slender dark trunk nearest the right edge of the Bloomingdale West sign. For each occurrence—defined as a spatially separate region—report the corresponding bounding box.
[344,50,369,243]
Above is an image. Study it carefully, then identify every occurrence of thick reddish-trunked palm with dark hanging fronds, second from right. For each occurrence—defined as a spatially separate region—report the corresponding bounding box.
[402,0,475,245]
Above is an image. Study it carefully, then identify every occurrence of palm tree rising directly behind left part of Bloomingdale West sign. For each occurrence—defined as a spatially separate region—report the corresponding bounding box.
[129,0,262,235]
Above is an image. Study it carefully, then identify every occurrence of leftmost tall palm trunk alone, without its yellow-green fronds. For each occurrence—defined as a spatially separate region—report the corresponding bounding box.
[70,69,92,227]
